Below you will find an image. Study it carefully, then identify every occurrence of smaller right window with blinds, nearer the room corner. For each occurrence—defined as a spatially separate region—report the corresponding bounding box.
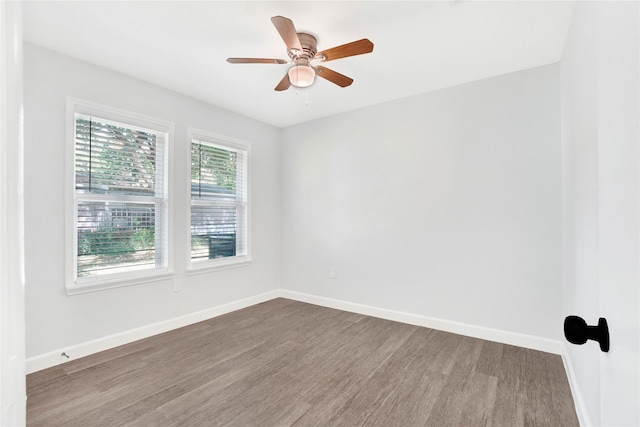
[190,131,250,269]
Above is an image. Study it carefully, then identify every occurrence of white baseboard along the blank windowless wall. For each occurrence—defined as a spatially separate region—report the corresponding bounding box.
[280,289,562,354]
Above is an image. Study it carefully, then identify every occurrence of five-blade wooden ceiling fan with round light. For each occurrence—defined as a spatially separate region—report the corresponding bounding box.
[227,16,373,91]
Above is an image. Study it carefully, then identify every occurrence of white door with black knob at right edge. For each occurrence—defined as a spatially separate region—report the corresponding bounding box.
[593,2,640,426]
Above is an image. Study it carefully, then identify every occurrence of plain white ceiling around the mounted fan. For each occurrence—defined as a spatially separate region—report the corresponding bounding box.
[23,0,573,127]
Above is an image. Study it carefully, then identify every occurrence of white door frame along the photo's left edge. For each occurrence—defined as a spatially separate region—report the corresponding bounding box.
[0,1,27,426]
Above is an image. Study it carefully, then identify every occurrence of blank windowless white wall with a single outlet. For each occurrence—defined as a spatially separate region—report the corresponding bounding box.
[281,65,562,340]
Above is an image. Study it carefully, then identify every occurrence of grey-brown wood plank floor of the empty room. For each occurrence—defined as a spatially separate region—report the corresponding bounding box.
[27,298,578,427]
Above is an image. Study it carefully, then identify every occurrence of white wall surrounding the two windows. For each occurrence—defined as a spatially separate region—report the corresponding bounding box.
[24,45,280,358]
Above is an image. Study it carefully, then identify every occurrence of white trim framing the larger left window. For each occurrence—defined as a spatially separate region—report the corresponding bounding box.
[64,97,174,295]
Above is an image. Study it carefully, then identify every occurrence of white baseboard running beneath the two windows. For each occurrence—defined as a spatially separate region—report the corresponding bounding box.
[26,289,281,374]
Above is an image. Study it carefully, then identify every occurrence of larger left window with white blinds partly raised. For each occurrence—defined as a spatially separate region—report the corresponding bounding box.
[67,100,171,293]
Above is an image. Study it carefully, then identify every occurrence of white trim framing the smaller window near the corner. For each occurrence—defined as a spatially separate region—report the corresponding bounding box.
[186,127,252,276]
